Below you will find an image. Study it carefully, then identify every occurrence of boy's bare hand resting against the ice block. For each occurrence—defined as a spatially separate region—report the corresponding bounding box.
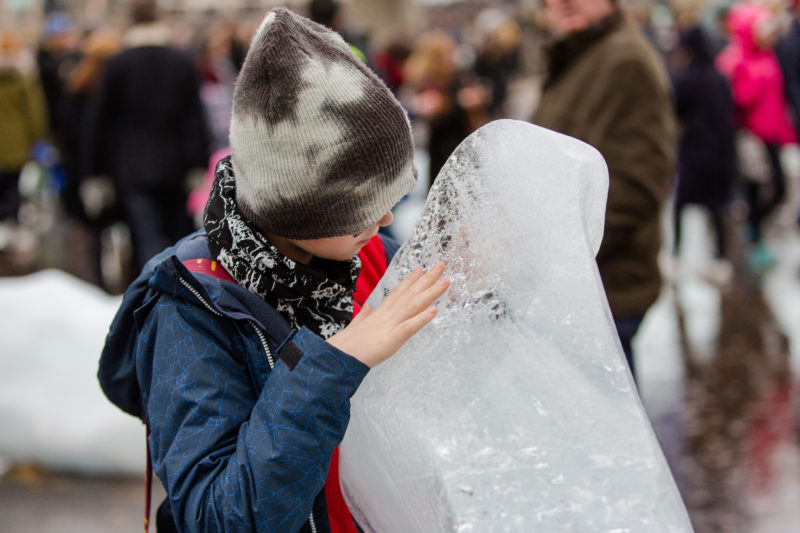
[328,261,450,368]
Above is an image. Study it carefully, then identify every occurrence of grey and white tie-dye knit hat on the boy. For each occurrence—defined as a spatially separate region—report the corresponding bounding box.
[230,8,417,239]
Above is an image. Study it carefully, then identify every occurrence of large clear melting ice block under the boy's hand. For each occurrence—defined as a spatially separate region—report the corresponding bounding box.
[340,120,691,533]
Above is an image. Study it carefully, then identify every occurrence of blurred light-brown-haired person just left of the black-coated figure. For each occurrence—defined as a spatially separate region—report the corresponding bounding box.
[61,29,122,290]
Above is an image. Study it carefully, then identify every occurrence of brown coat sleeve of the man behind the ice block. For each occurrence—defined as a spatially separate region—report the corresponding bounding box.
[589,56,676,261]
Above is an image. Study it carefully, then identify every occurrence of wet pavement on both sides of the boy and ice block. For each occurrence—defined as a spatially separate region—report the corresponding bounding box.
[0,196,800,533]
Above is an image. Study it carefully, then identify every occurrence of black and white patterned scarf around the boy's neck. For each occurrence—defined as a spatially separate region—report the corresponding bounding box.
[203,157,361,339]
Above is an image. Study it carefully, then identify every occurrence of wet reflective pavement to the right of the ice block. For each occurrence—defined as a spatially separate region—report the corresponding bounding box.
[636,209,800,533]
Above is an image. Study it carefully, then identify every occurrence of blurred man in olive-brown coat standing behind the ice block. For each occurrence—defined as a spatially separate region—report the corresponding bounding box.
[532,0,675,377]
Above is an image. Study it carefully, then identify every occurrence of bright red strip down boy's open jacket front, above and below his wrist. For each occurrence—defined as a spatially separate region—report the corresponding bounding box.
[325,235,387,533]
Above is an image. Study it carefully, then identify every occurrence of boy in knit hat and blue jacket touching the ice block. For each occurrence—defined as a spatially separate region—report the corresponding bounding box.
[99,8,448,532]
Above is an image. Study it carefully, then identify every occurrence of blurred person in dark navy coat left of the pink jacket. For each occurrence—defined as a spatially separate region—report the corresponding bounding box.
[673,26,736,284]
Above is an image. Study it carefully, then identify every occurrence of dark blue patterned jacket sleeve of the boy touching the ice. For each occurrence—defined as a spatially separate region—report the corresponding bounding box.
[137,302,368,532]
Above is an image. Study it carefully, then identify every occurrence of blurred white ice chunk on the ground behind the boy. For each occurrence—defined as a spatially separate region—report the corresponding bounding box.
[0,270,145,476]
